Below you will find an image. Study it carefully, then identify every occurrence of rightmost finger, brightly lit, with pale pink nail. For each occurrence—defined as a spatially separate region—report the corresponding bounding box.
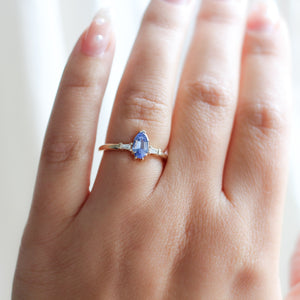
[224,5,291,213]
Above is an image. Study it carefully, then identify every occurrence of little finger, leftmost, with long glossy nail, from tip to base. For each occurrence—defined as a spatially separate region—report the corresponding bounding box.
[33,10,114,225]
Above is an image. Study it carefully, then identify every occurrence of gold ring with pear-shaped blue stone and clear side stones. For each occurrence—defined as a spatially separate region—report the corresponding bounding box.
[99,130,168,160]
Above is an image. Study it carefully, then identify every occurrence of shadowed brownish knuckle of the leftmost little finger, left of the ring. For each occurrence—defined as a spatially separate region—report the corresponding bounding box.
[42,136,88,164]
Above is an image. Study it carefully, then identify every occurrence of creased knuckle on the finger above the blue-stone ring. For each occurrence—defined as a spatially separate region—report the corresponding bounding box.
[123,92,170,125]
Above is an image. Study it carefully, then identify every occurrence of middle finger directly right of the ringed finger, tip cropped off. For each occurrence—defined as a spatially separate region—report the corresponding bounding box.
[169,0,247,188]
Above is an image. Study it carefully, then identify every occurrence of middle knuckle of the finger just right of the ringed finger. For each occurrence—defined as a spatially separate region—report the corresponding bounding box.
[186,79,234,108]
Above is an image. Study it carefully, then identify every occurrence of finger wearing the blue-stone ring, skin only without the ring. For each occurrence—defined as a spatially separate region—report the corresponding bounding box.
[95,0,197,197]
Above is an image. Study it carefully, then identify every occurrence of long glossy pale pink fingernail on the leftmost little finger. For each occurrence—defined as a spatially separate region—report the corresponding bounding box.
[81,8,111,56]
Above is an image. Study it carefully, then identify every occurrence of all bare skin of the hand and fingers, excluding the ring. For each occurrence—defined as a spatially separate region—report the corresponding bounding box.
[12,0,300,300]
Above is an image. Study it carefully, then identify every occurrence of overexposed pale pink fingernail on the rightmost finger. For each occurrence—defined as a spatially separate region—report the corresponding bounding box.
[247,0,280,31]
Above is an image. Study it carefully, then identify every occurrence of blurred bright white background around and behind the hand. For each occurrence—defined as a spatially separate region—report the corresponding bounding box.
[0,0,300,300]
